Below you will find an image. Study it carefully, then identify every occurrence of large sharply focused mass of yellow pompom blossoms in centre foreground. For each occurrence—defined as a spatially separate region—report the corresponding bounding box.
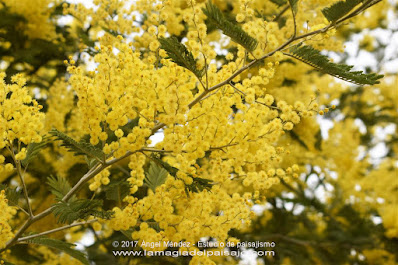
[59,1,336,252]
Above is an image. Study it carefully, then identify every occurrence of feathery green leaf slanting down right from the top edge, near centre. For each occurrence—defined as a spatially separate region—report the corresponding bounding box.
[202,0,258,51]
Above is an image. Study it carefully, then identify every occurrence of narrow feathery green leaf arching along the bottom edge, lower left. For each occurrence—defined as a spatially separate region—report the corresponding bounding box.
[26,237,90,265]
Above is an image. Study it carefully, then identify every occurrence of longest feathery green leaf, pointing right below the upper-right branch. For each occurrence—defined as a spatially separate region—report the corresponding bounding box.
[285,45,383,85]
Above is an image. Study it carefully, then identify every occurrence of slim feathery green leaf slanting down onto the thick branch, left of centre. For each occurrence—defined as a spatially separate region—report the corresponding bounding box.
[50,129,105,161]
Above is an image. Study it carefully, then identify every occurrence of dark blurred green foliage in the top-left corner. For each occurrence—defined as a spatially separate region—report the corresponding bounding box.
[0,1,77,87]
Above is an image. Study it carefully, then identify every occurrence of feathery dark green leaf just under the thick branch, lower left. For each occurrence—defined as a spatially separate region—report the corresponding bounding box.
[52,199,113,224]
